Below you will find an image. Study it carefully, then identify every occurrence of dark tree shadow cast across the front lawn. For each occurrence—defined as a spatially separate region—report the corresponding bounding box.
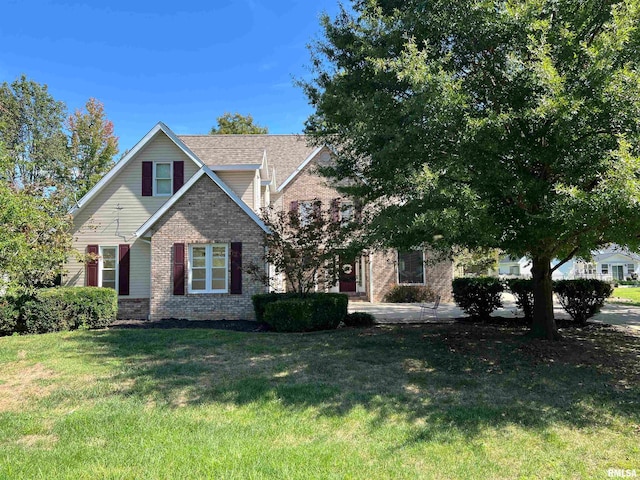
[68,324,640,442]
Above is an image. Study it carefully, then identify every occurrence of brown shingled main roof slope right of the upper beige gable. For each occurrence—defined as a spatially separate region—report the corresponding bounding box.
[178,134,321,189]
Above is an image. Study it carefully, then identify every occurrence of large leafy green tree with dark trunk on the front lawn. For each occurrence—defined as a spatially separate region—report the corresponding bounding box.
[304,0,640,339]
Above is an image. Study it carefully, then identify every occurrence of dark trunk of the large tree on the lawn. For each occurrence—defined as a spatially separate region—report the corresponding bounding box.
[531,256,562,340]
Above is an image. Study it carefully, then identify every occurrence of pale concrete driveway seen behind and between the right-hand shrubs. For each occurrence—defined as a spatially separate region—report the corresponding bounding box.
[349,294,640,331]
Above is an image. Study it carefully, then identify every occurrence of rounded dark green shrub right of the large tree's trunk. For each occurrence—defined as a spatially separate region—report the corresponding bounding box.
[553,278,613,324]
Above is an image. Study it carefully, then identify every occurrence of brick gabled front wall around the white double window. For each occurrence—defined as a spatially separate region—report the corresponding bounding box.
[150,176,265,320]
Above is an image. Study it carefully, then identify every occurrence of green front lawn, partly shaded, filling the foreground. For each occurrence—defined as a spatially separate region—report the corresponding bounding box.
[0,325,640,479]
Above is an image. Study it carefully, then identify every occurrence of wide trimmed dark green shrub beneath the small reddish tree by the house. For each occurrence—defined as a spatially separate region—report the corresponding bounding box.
[263,293,349,332]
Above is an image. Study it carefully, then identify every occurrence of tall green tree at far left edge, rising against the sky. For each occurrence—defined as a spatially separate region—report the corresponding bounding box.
[0,75,70,191]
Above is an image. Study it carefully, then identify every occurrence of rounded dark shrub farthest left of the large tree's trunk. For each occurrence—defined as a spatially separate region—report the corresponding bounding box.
[452,277,504,320]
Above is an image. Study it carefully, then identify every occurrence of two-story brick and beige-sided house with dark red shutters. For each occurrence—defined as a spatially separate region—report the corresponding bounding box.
[64,123,453,320]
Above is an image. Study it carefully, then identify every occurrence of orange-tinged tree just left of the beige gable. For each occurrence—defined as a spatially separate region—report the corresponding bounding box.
[67,98,118,198]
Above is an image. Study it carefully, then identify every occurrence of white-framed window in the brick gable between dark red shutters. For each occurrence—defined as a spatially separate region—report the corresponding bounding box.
[189,243,229,293]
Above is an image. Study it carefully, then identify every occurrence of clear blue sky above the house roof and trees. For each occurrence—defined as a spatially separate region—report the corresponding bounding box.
[0,0,338,152]
